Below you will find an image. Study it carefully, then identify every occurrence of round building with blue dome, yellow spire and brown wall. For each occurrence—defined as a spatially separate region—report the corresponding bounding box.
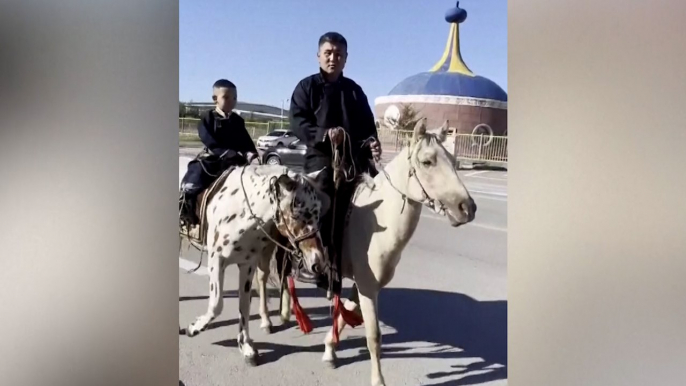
[374,1,507,136]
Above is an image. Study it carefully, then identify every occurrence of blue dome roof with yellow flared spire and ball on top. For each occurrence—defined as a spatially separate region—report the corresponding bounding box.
[389,1,507,102]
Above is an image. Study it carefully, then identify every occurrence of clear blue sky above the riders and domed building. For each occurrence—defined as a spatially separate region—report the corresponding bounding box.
[179,0,507,113]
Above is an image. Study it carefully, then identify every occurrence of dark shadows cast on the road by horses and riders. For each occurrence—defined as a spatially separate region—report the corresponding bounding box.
[189,288,507,386]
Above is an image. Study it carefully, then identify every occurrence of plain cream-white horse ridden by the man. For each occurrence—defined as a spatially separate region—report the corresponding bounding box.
[257,120,476,386]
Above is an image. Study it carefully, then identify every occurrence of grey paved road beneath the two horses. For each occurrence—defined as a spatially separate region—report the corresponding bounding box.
[179,150,507,386]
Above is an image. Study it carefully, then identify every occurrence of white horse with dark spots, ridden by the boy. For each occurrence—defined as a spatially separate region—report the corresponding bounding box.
[179,161,329,365]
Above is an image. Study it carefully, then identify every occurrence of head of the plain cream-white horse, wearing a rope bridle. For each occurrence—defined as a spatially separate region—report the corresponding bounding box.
[407,119,476,227]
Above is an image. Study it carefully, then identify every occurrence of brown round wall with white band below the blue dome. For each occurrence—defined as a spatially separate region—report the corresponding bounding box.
[374,103,507,136]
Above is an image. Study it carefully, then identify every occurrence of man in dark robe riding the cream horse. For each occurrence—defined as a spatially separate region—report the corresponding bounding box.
[289,32,381,294]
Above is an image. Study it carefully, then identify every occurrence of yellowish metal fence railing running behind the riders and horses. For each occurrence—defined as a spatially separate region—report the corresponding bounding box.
[179,118,507,165]
